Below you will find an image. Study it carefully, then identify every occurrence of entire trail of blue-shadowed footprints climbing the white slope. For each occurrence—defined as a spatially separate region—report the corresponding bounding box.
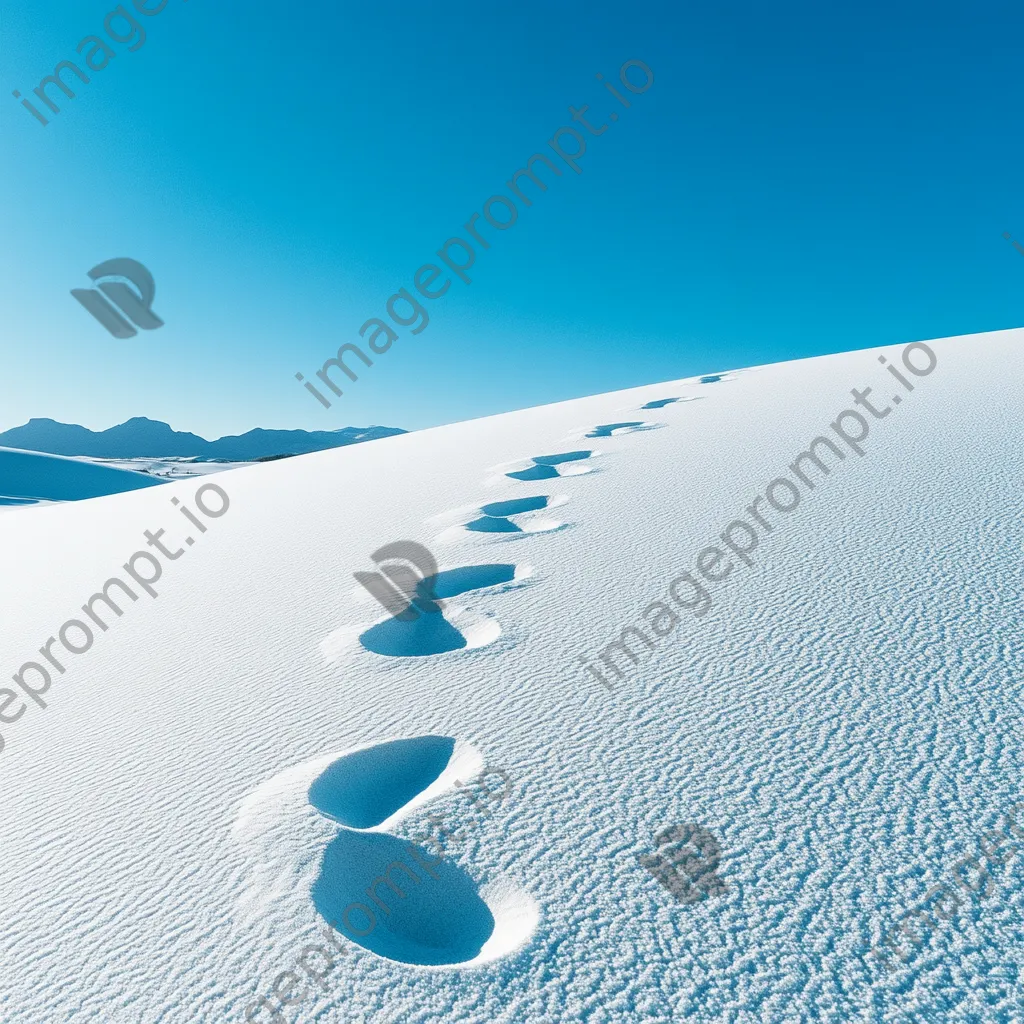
[248,375,728,968]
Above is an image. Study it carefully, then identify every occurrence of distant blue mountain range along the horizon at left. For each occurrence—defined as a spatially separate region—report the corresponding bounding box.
[0,416,407,462]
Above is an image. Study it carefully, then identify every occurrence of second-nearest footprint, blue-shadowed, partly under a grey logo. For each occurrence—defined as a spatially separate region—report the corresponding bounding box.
[359,563,532,657]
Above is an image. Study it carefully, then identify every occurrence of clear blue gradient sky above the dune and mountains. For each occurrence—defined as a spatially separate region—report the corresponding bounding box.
[0,0,1024,436]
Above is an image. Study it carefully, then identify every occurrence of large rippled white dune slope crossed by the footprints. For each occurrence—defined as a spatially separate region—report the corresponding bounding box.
[0,331,1024,1024]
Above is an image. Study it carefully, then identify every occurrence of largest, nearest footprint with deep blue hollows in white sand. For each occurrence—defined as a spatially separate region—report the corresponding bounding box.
[308,736,538,967]
